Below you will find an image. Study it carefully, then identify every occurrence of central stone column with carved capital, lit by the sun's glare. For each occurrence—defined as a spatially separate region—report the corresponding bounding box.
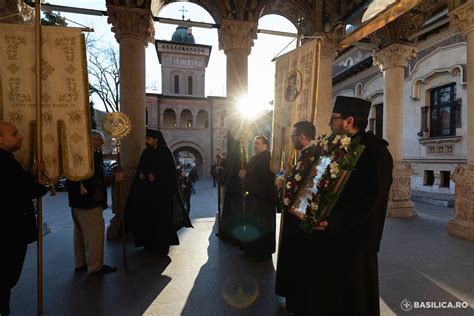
[219,19,257,135]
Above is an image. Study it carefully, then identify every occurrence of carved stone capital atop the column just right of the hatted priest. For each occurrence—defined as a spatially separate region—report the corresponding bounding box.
[373,43,417,71]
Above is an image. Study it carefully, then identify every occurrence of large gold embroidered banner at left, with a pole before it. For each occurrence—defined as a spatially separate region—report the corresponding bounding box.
[0,24,93,181]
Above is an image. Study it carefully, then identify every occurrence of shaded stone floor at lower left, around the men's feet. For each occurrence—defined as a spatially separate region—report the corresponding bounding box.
[11,230,171,316]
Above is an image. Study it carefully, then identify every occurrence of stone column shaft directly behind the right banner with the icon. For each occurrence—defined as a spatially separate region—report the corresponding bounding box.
[314,33,338,135]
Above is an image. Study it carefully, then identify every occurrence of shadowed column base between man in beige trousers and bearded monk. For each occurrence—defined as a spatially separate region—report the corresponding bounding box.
[106,168,137,241]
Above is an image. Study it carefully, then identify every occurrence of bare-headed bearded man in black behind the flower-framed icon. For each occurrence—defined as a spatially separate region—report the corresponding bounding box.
[276,121,324,315]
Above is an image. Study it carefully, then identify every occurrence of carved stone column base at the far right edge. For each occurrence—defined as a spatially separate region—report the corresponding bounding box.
[447,166,474,240]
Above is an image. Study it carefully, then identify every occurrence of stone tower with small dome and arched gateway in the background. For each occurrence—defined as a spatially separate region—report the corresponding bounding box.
[146,26,231,176]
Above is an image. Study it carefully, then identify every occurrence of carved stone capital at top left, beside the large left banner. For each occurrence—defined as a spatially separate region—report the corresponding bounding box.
[107,4,155,46]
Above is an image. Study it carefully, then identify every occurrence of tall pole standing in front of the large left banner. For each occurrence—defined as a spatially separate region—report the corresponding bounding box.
[35,0,43,315]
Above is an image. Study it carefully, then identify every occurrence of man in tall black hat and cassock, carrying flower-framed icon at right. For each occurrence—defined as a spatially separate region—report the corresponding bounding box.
[321,96,393,316]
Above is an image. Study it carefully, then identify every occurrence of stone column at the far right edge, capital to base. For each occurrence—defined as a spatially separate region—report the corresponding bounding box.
[447,0,474,240]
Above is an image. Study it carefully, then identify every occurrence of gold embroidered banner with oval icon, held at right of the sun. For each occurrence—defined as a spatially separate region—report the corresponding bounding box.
[271,40,320,172]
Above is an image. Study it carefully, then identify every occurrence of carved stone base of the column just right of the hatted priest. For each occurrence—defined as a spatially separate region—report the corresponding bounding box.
[387,163,416,218]
